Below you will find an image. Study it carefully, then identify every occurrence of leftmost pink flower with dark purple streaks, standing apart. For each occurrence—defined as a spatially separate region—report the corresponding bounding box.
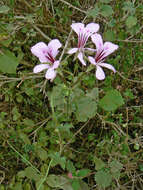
[31,39,62,81]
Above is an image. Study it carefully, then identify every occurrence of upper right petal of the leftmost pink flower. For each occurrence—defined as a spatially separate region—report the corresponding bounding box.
[48,39,62,58]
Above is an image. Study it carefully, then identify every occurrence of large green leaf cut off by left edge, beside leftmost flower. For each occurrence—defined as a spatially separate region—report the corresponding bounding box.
[0,51,19,74]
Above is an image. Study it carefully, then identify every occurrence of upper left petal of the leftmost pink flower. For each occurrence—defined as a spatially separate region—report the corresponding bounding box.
[31,42,48,63]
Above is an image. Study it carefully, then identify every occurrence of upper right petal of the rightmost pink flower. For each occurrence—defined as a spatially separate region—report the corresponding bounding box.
[104,42,118,57]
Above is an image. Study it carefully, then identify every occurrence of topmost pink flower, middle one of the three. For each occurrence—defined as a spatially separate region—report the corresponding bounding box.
[68,23,99,65]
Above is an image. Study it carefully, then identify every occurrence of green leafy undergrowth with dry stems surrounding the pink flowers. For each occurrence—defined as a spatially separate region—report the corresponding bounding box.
[0,0,143,190]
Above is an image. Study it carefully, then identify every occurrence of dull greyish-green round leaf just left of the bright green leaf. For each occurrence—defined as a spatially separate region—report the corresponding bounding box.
[75,97,97,122]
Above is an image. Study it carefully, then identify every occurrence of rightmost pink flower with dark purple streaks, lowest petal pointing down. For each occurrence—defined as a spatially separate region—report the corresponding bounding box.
[88,34,118,80]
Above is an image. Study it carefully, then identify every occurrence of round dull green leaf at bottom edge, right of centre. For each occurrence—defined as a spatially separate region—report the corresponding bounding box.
[95,171,112,188]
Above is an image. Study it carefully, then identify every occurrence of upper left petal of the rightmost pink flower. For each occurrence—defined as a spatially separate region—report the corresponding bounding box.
[91,34,103,52]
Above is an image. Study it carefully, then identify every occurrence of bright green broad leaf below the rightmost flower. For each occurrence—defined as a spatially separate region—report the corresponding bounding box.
[99,90,124,111]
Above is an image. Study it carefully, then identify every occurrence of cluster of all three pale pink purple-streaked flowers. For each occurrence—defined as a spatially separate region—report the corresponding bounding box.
[31,23,118,81]
